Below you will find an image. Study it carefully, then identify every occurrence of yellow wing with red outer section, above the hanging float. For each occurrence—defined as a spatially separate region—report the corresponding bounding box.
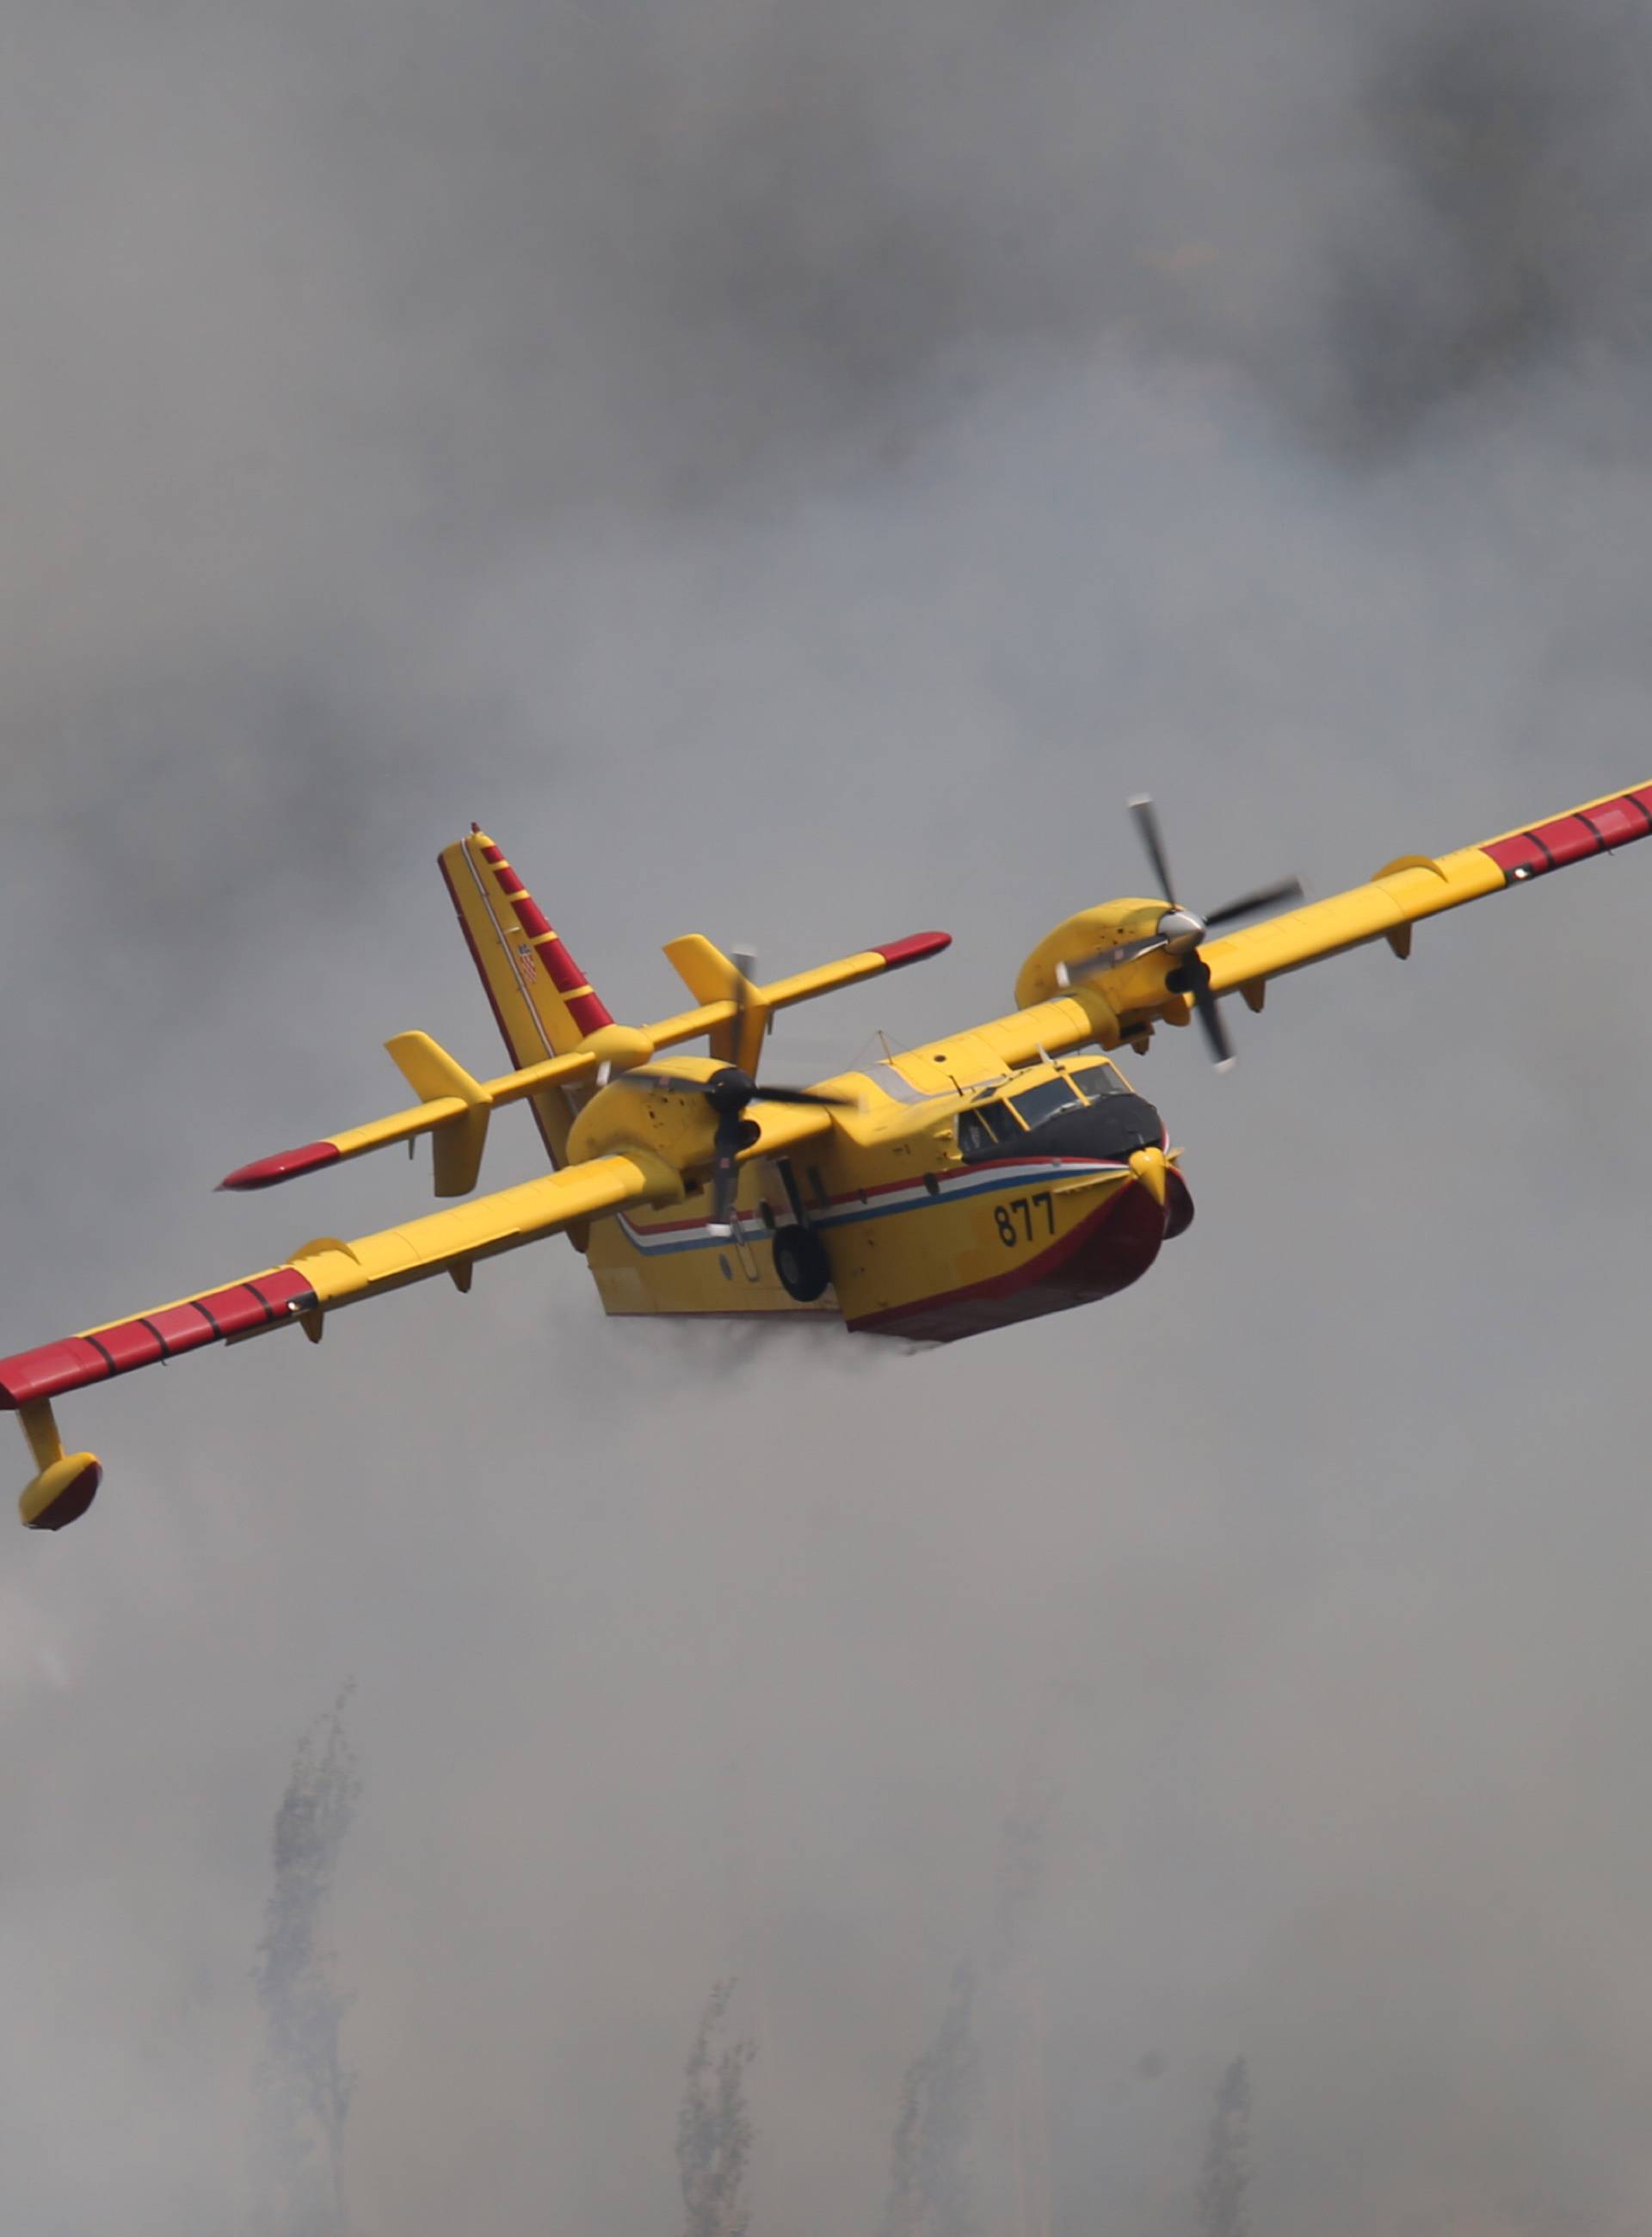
[0,1152,681,1409]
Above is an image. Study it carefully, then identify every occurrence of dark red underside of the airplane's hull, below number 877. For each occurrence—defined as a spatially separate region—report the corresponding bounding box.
[848,1170,1193,1345]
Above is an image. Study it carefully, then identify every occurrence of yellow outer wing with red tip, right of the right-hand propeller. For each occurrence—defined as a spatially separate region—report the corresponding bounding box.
[1199,786,1652,1000]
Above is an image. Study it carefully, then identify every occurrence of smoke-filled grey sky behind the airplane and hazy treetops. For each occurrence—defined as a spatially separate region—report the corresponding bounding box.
[0,0,1652,2237]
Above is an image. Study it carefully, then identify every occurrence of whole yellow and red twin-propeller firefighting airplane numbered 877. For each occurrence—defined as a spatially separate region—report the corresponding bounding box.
[0,786,1652,1530]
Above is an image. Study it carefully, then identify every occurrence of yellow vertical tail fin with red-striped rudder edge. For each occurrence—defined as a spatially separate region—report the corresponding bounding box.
[439,825,613,1166]
